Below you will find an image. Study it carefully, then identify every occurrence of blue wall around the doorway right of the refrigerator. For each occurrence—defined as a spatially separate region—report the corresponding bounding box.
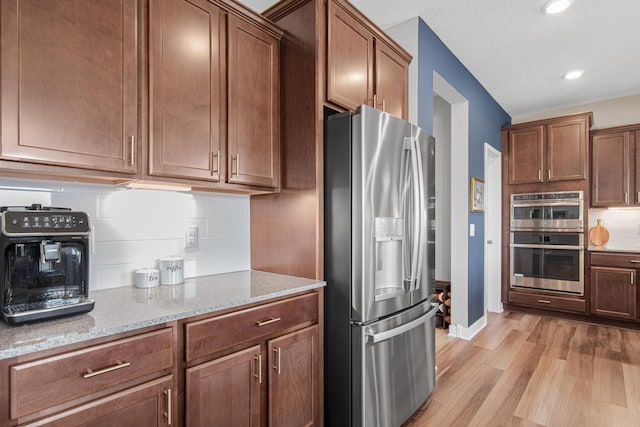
[418,19,511,326]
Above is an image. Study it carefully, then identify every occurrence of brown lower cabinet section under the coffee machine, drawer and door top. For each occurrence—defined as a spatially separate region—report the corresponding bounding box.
[0,327,177,427]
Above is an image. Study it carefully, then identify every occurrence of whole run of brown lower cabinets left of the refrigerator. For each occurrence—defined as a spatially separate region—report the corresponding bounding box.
[0,290,323,427]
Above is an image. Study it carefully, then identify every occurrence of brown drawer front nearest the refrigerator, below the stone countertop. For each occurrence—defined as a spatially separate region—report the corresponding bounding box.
[185,292,318,362]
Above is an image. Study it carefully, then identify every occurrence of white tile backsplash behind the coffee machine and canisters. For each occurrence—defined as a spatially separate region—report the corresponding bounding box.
[0,178,250,290]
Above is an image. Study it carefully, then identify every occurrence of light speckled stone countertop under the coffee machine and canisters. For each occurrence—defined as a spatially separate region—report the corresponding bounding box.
[0,270,326,360]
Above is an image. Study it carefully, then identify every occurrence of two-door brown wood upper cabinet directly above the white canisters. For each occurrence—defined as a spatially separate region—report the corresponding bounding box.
[149,0,281,188]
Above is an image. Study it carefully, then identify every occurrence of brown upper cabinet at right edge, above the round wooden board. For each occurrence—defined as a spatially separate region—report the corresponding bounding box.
[591,125,640,207]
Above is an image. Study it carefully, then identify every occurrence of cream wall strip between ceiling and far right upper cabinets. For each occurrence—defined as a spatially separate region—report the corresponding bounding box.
[511,94,640,129]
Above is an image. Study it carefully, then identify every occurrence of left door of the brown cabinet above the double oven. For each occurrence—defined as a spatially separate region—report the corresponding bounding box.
[509,126,544,184]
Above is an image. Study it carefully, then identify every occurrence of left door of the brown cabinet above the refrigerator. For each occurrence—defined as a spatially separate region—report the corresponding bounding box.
[327,1,374,110]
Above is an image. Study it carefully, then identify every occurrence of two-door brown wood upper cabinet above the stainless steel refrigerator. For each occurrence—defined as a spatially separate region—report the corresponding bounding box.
[327,0,411,119]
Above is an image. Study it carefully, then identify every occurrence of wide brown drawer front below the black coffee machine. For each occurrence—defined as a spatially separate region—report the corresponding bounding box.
[9,328,173,419]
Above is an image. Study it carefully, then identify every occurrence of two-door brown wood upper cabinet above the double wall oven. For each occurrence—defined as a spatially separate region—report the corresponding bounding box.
[504,113,591,184]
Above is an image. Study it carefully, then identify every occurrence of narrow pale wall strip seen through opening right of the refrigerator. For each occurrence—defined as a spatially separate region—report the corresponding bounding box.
[433,96,451,282]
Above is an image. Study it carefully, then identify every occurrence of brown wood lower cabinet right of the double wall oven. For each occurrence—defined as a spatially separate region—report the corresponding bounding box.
[590,252,640,320]
